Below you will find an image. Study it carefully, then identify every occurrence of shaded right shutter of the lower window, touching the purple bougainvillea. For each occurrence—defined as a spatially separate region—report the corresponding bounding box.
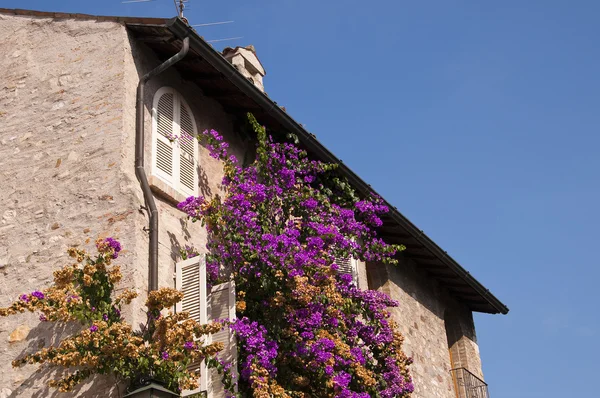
[207,281,237,398]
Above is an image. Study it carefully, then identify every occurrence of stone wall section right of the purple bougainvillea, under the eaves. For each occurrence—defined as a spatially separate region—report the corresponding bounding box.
[367,255,483,398]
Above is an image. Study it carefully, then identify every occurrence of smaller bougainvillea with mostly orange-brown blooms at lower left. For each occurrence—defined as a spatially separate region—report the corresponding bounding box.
[0,238,223,391]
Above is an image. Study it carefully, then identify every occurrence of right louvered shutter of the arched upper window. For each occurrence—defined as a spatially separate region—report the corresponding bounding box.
[179,99,198,195]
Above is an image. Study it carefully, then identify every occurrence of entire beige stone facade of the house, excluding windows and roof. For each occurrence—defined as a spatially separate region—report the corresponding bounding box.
[0,10,488,398]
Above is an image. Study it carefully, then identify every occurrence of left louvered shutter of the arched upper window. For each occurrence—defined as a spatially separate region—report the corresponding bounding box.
[152,91,176,185]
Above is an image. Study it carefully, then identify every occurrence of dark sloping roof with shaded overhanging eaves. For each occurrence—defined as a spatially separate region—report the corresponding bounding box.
[0,9,509,314]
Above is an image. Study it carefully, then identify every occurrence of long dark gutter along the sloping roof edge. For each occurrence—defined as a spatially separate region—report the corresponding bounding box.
[167,18,509,314]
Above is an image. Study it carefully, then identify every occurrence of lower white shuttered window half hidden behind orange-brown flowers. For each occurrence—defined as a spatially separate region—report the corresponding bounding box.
[175,255,237,398]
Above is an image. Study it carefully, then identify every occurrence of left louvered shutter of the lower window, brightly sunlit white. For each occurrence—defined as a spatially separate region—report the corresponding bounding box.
[175,256,210,396]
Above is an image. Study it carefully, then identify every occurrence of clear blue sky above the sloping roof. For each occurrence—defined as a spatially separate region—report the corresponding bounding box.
[5,0,600,398]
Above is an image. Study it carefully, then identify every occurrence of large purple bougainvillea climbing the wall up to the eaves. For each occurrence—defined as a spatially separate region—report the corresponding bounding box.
[179,115,413,398]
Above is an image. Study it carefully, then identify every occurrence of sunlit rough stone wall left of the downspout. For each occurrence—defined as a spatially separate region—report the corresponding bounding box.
[0,15,145,397]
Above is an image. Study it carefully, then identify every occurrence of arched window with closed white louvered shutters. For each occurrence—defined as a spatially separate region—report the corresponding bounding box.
[152,87,198,196]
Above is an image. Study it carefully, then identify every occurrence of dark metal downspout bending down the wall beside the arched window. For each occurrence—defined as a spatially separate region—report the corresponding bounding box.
[135,37,190,292]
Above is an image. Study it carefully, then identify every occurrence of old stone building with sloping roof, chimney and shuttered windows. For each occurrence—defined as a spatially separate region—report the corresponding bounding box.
[0,9,508,398]
